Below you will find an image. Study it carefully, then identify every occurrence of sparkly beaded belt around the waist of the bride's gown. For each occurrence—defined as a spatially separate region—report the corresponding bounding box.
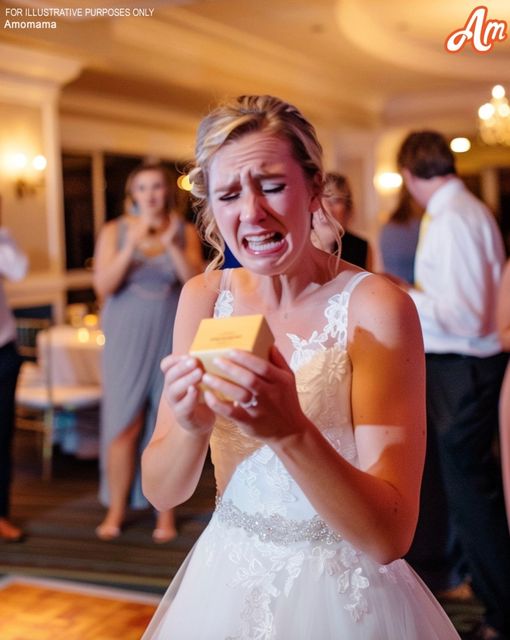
[215,497,342,545]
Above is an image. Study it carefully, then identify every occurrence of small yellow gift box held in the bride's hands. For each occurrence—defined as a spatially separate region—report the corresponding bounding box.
[190,314,274,382]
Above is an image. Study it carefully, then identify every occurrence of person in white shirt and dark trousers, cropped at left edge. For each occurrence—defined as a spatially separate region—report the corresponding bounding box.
[0,221,28,542]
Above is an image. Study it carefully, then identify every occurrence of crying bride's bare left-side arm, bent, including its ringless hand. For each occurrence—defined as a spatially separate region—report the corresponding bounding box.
[142,274,219,510]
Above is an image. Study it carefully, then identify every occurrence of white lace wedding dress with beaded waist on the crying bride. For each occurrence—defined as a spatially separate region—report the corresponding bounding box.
[142,273,459,640]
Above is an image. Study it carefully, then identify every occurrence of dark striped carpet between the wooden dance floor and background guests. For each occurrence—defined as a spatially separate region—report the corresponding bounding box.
[0,433,214,594]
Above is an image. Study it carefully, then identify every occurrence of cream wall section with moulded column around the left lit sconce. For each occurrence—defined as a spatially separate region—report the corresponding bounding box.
[0,43,81,320]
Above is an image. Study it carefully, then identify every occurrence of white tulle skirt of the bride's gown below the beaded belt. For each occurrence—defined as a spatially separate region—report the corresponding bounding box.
[142,513,459,640]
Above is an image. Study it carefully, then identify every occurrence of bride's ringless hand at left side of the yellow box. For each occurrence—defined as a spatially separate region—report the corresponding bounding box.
[161,355,215,434]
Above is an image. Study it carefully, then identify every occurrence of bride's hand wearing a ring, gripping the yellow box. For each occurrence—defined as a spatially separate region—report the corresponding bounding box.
[203,346,304,442]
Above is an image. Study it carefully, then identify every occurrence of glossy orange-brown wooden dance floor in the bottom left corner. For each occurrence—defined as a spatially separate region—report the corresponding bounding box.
[0,578,156,640]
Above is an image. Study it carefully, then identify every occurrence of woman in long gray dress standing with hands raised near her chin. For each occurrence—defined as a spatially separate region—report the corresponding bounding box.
[94,164,203,542]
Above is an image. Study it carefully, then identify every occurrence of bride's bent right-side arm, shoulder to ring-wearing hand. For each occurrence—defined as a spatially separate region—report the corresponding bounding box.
[204,276,425,563]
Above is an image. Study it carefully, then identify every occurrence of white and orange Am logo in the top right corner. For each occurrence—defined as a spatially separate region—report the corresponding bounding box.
[444,6,507,53]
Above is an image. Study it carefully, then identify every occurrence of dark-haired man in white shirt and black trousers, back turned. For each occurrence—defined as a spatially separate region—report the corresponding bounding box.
[398,131,510,640]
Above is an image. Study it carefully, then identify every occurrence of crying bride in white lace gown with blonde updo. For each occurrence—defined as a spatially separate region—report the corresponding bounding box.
[138,96,459,640]
